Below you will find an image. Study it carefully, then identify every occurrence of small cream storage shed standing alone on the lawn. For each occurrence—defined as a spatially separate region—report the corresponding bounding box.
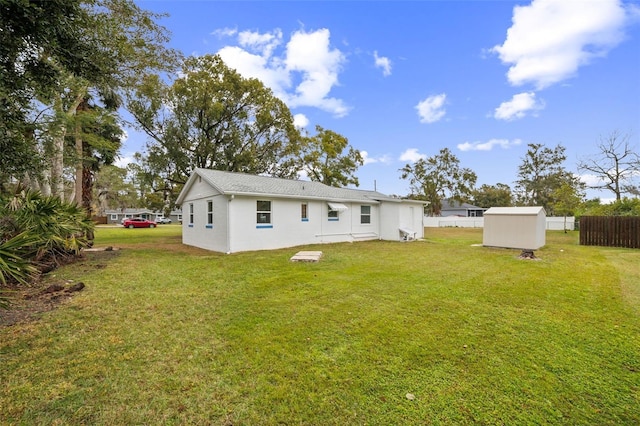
[482,207,547,250]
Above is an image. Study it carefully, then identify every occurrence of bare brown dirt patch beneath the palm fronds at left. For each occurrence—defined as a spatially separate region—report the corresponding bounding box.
[0,251,118,327]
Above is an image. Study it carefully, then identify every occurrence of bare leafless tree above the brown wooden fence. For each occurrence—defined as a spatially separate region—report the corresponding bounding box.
[578,131,640,201]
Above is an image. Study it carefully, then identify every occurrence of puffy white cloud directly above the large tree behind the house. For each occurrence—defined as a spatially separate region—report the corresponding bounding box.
[218,28,350,117]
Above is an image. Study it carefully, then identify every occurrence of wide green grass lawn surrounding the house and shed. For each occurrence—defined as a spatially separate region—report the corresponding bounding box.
[0,226,640,425]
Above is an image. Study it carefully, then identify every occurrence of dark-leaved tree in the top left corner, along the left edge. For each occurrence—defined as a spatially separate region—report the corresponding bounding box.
[0,0,101,184]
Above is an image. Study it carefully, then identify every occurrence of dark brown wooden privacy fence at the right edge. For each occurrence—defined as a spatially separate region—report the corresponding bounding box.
[580,216,640,248]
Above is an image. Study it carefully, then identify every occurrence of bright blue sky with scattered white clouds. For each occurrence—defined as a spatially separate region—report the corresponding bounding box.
[122,0,640,200]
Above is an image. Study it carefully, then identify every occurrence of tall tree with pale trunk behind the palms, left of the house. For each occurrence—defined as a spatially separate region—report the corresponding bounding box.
[2,0,179,201]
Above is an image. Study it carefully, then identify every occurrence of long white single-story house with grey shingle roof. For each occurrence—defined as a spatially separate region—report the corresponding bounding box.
[177,169,424,253]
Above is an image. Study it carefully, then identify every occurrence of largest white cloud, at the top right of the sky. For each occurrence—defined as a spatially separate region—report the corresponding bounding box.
[491,0,633,89]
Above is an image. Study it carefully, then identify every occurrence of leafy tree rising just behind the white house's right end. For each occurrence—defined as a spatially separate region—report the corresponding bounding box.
[400,148,477,216]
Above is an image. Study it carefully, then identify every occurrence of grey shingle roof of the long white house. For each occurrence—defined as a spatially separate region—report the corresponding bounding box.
[176,168,424,204]
